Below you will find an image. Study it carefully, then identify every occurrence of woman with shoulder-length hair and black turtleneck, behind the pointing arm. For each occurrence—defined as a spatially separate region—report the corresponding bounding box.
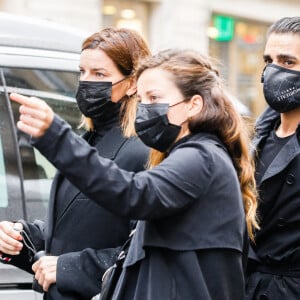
[0,28,150,300]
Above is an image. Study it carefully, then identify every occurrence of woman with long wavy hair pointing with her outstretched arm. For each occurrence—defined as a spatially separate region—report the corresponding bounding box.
[11,51,257,300]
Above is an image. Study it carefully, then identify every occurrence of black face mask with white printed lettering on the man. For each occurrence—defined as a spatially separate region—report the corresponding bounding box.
[262,64,300,113]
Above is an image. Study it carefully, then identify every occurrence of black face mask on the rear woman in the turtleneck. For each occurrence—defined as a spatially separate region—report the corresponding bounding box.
[76,78,126,121]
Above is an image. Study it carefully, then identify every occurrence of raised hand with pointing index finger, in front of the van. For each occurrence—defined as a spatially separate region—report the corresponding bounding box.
[10,93,54,138]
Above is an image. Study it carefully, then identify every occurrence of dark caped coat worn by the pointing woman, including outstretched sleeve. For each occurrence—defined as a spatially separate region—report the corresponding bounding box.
[35,117,247,300]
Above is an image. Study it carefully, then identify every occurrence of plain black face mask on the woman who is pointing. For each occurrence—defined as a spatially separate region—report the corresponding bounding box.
[135,101,182,152]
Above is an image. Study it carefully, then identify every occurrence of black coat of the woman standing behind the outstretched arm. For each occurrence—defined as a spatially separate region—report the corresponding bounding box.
[12,126,148,300]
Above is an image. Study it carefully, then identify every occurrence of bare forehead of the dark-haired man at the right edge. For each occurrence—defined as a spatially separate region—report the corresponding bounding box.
[264,33,300,59]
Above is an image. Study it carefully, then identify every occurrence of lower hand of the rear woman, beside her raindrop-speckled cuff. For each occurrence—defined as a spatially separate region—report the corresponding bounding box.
[32,255,58,292]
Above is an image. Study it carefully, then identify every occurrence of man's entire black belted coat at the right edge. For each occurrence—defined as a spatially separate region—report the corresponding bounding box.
[247,108,300,300]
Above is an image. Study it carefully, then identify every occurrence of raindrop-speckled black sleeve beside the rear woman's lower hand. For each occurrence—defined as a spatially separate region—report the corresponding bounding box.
[56,247,121,299]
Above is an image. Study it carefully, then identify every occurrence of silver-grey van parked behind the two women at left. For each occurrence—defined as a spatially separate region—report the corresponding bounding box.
[0,13,89,300]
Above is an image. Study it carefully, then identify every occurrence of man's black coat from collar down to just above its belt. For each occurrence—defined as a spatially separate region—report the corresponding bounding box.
[250,108,300,270]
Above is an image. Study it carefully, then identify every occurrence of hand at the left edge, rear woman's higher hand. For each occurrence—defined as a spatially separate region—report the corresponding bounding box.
[0,221,23,255]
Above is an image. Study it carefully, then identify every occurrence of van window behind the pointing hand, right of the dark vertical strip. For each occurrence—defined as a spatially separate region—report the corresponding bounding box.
[3,68,81,221]
